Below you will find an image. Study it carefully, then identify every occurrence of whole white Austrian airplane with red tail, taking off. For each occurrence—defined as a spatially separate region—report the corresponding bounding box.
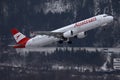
[11,14,113,48]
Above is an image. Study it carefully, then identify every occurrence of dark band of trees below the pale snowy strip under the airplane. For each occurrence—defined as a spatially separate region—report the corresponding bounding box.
[0,50,106,67]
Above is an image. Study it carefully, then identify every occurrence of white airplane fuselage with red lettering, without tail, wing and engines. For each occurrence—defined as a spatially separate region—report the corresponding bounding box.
[25,14,113,48]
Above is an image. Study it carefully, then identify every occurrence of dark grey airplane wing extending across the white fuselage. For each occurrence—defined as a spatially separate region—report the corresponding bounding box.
[30,31,63,38]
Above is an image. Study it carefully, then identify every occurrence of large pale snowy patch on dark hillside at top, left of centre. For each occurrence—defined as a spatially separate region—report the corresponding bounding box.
[34,0,72,14]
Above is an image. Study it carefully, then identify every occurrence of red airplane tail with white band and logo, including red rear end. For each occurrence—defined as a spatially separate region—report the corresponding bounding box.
[11,28,29,48]
